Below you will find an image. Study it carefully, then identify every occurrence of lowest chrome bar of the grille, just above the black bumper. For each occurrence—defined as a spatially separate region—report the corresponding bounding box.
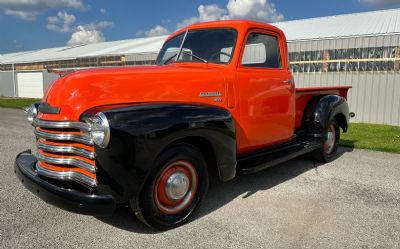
[36,162,97,187]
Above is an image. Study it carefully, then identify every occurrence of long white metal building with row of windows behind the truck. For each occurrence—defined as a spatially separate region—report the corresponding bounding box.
[0,9,400,125]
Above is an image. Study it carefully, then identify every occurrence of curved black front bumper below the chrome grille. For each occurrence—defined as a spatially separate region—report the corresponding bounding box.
[15,152,116,216]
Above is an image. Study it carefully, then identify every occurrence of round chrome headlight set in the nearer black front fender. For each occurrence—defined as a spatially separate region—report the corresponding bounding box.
[89,112,110,148]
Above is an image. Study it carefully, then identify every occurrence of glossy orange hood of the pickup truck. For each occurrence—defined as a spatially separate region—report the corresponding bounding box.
[38,63,226,121]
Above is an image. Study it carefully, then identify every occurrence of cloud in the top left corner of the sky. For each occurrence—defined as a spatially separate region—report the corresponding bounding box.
[0,0,85,20]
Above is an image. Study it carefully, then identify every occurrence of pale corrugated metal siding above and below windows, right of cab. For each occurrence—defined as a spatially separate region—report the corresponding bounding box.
[289,35,400,125]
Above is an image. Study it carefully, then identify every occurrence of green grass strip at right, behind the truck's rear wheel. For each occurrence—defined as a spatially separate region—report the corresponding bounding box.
[340,123,400,153]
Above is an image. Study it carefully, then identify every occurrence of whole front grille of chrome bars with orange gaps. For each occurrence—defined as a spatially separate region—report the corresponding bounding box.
[33,119,97,187]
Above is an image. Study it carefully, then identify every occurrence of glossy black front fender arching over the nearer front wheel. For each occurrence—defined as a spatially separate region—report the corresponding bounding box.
[89,103,236,202]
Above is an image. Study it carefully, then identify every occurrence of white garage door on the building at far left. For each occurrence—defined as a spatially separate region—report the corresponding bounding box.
[17,72,43,98]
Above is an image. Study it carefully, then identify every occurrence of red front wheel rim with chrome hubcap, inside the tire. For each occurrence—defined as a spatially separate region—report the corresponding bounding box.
[154,161,198,214]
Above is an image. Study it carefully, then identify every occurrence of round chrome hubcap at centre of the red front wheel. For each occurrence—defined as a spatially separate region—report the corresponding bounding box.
[165,172,190,200]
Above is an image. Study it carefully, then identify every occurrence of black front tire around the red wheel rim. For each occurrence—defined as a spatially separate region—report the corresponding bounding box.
[130,143,209,230]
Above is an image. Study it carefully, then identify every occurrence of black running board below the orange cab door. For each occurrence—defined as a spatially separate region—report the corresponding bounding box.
[238,141,321,174]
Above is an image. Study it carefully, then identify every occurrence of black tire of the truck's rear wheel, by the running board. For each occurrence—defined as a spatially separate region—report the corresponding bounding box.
[311,119,340,163]
